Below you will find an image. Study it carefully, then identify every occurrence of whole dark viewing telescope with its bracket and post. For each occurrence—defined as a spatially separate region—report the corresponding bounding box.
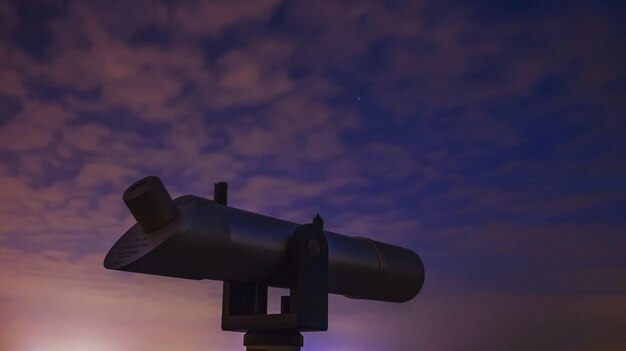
[104,176,424,351]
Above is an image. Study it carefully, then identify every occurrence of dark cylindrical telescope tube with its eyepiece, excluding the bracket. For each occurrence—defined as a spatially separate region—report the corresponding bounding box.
[104,178,424,302]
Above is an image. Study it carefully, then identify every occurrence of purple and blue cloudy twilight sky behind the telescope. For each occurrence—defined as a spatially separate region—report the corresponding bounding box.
[0,0,626,351]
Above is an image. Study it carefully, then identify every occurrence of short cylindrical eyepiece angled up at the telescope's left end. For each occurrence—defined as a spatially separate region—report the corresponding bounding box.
[122,176,178,232]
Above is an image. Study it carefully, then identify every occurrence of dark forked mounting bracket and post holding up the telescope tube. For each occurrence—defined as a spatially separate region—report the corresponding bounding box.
[214,183,328,351]
